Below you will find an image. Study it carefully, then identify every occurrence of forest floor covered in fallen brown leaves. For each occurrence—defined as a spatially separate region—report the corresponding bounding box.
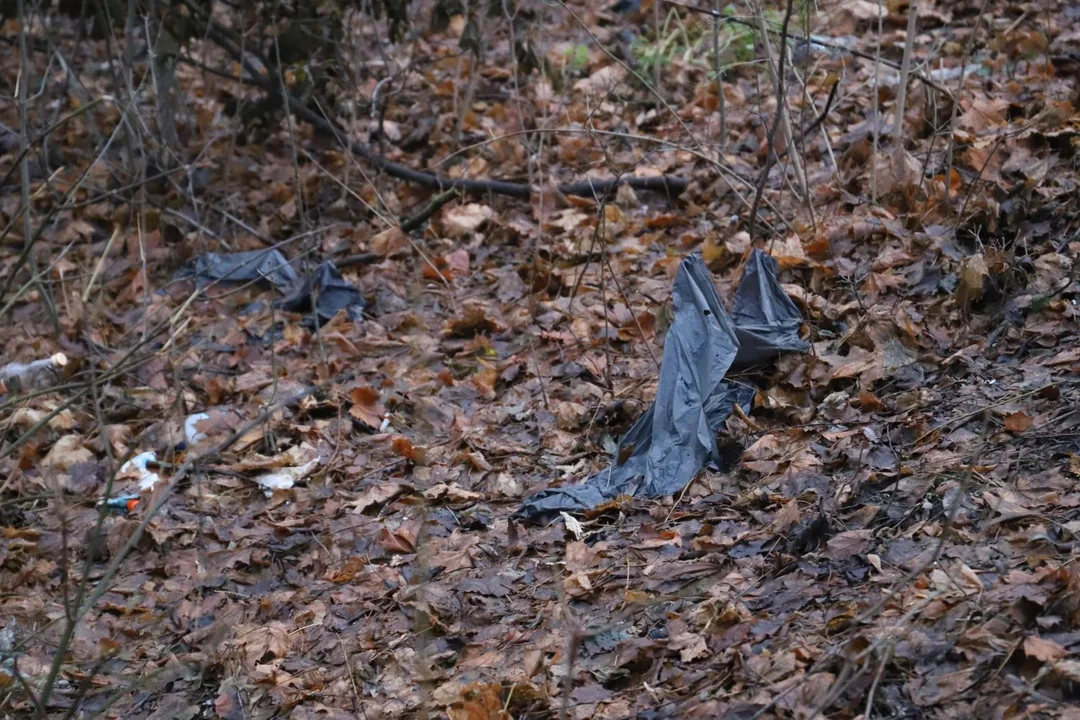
[0,0,1080,720]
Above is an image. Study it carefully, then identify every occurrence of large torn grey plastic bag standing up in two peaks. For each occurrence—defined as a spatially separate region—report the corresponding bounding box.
[517,249,809,519]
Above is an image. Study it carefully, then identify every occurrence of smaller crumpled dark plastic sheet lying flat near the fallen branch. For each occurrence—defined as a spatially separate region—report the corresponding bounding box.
[177,248,364,326]
